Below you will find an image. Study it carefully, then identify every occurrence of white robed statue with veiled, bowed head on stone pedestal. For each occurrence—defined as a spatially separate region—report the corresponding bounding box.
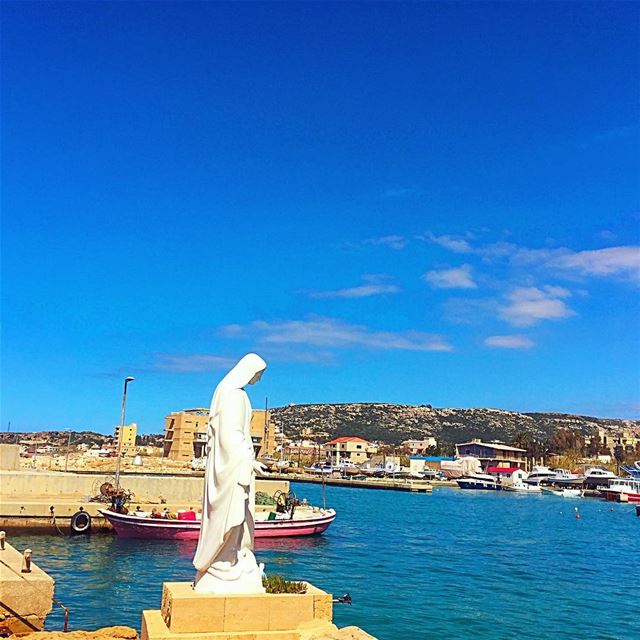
[193,353,267,594]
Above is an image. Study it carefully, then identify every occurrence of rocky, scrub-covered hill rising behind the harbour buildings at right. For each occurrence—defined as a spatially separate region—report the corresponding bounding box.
[272,403,640,445]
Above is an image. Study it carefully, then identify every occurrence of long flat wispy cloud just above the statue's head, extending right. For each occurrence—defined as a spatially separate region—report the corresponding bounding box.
[222,317,453,351]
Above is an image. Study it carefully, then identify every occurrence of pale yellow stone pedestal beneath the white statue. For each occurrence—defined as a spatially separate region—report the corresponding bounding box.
[141,582,335,640]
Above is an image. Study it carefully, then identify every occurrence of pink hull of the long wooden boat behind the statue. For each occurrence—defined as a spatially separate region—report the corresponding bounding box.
[99,509,336,540]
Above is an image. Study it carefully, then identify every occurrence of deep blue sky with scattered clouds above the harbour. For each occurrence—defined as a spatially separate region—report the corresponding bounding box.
[1,2,640,432]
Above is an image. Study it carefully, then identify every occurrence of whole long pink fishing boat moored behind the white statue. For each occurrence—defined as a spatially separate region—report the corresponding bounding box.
[98,505,336,540]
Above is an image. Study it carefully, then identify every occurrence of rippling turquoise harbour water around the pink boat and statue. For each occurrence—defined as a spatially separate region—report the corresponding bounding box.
[11,484,640,640]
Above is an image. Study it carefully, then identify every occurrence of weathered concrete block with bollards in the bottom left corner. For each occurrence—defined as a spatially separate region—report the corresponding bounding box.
[0,543,53,633]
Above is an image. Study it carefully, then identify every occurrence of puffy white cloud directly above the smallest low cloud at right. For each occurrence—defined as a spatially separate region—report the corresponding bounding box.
[498,287,575,327]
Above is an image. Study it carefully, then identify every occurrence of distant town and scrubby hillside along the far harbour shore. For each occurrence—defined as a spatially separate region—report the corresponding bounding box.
[0,405,640,473]
